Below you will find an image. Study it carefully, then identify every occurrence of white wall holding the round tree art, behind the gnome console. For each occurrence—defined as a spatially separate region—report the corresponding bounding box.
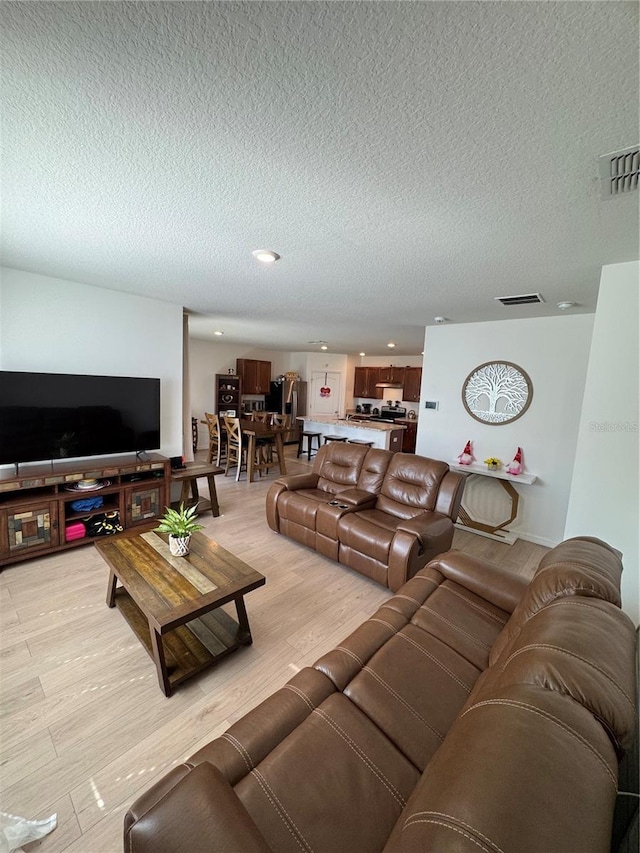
[416,314,593,546]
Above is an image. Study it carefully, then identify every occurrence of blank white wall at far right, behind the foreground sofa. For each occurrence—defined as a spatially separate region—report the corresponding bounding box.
[565,261,640,624]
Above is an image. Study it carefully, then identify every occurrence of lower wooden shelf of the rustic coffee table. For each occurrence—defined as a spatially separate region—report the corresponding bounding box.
[115,587,252,696]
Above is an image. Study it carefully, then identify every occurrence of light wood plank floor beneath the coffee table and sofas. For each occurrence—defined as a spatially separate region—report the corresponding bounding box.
[0,447,546,853]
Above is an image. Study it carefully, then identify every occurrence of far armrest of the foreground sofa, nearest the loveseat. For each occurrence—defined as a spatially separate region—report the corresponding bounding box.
[429,550,530,613]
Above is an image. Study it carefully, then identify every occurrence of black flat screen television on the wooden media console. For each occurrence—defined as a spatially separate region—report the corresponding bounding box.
[0,370,160,465]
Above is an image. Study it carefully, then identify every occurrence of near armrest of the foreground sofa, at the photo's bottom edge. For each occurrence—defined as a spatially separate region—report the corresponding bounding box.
[124,762,272,853]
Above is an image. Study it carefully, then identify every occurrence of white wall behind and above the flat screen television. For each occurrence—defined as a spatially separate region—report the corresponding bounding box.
[0,268,182,456]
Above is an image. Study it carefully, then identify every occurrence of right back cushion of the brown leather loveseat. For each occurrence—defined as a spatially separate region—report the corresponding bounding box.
[376,453,449,518]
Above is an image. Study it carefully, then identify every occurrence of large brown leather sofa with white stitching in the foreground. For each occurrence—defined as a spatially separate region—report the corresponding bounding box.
[124,539,637,853]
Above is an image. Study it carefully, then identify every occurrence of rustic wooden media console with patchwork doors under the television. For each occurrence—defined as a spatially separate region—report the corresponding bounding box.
[0,453,170,568]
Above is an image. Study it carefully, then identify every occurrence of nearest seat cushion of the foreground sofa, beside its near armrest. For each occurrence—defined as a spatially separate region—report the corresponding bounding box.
[235,694,420,853]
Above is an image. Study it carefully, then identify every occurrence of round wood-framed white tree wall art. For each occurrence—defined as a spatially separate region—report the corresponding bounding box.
[462,361,533,426]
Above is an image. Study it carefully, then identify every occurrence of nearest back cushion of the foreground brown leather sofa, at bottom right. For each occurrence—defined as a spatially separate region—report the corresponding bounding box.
[384,685,617,853]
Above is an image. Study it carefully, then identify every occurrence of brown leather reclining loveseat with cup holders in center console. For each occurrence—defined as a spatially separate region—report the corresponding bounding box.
[267,442,465,592]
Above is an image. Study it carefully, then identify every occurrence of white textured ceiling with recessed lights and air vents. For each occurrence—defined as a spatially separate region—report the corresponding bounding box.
[0,2,638,355]
